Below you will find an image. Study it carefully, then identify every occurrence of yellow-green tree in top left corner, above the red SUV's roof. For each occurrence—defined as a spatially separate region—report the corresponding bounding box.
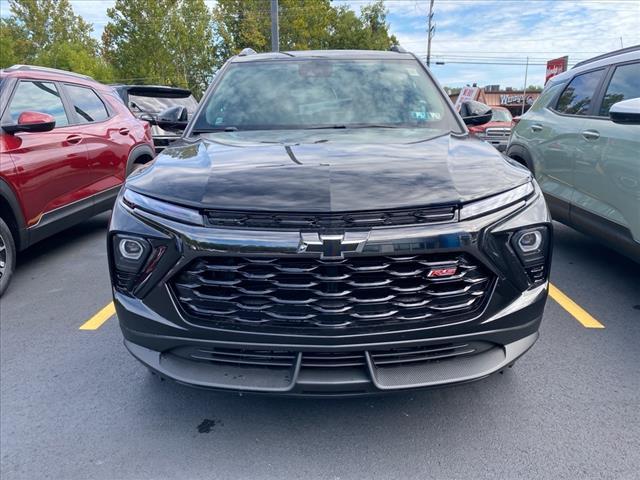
[0,0,111,80]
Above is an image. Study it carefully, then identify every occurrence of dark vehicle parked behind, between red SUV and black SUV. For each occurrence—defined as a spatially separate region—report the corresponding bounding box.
[112,85,198,153]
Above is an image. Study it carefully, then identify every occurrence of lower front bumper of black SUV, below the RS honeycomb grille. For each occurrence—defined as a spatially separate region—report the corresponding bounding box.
[116,284,547,396]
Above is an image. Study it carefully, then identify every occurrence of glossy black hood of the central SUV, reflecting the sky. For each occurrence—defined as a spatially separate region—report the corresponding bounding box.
[127,135,530,212]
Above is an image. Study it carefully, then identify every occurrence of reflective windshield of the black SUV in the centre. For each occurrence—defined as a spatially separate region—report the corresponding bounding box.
[194,59,459,133]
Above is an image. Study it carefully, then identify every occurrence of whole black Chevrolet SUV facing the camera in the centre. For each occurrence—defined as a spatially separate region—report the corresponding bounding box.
[108,51,552,395]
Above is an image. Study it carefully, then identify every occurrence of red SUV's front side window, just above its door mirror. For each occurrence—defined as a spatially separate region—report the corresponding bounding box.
[8,81,69,127]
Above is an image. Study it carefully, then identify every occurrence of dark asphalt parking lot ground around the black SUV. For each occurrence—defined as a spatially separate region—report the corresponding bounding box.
[0,214,640,480]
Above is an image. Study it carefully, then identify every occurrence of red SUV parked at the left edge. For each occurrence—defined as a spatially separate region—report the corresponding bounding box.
[0,65,155,295]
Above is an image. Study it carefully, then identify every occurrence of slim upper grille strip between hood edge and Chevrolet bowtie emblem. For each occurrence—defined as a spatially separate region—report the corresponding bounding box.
[205,206,455,232]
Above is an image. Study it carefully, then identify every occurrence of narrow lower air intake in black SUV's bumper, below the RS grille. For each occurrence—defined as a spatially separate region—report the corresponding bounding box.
[171,342,493,369]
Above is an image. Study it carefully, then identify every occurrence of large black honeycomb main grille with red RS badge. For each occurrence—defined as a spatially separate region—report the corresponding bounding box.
[171,254,493,335]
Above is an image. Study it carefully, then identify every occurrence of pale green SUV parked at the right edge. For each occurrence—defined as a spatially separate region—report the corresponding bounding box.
[507,46,640,262]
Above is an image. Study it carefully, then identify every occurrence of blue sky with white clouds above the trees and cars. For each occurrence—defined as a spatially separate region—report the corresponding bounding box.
[0,0,640,88]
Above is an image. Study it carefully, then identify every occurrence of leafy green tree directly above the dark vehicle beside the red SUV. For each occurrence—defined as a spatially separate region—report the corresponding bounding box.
[102,0,216,96]
